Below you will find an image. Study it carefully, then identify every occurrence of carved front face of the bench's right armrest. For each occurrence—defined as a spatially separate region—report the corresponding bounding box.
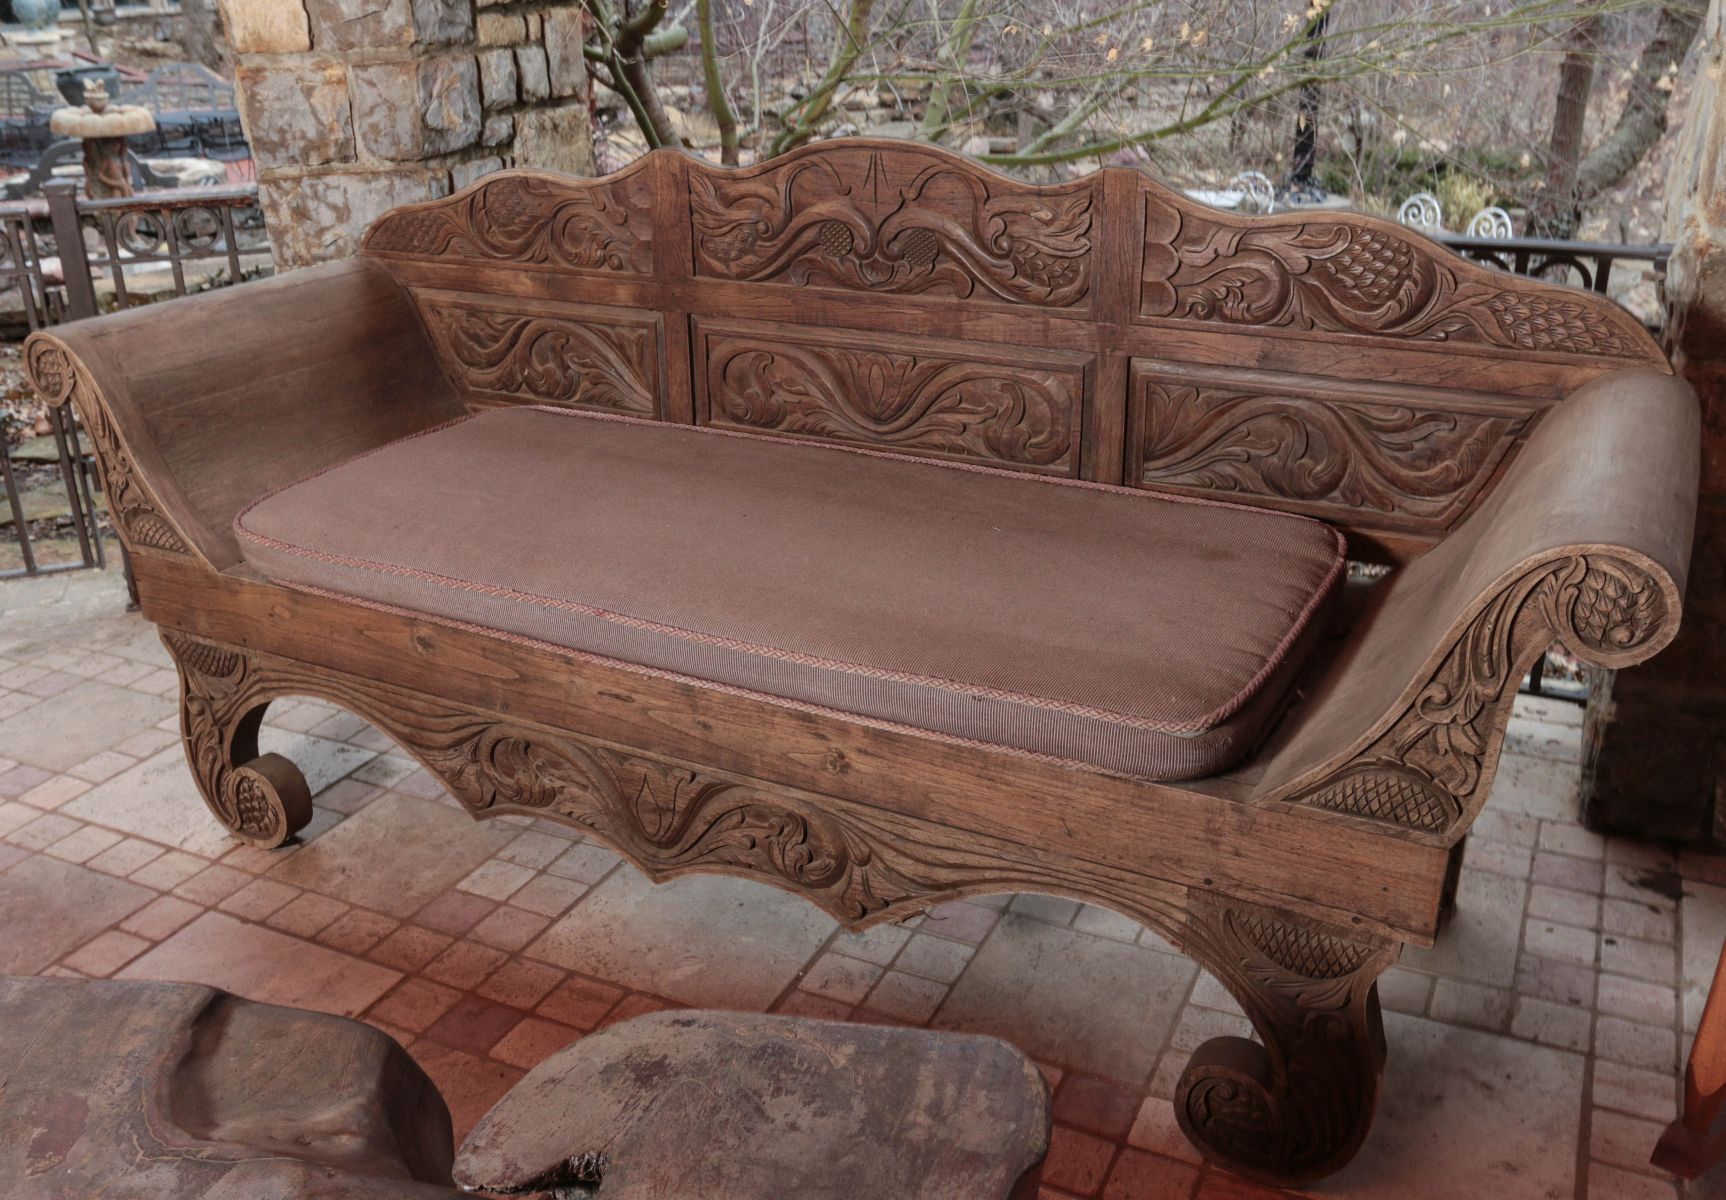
[1289,554,1671,844]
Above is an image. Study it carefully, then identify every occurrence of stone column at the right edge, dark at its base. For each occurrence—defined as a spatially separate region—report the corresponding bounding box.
[1583,0,1726,844]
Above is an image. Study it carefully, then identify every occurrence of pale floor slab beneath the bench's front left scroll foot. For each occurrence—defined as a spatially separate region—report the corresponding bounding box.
[62,729,376,856]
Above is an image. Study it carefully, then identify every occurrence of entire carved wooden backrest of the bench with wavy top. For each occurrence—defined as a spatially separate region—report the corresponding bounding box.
[366,138,1667,556]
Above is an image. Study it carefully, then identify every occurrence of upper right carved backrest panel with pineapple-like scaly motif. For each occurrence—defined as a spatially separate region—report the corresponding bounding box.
[1139,185,1664,364]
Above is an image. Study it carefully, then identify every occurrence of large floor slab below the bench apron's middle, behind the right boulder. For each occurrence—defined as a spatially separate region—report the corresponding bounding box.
[526,868,835,1010]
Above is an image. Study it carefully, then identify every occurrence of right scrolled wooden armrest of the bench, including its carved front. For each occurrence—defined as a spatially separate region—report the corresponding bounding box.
[1255,371,1698,846]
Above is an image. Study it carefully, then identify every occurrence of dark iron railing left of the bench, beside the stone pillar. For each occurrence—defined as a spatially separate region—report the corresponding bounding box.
[0,181,269,578]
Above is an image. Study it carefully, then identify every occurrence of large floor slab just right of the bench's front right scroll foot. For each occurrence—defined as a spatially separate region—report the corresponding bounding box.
[1313,1014,1593,1200]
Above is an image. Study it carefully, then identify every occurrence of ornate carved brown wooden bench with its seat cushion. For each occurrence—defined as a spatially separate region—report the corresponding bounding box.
[28,142,1697,1181]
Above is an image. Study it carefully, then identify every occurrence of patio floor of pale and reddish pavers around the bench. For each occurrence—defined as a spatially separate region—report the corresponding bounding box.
[0,573,1726,1200]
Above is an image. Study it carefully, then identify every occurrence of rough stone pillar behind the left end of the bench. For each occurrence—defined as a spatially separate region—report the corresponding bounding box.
[221,0,594,268]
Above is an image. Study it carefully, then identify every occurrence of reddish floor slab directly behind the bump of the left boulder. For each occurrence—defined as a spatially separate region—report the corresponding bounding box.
[114,912,402,1017]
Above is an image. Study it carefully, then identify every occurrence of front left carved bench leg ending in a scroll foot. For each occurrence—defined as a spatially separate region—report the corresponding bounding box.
[162,630,312,849]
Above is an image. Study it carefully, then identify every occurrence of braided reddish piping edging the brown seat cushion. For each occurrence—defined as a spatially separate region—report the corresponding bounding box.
[233,404,1346,737]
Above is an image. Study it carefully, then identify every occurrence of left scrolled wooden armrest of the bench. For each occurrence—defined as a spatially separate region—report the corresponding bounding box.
[24,261,463,570]
